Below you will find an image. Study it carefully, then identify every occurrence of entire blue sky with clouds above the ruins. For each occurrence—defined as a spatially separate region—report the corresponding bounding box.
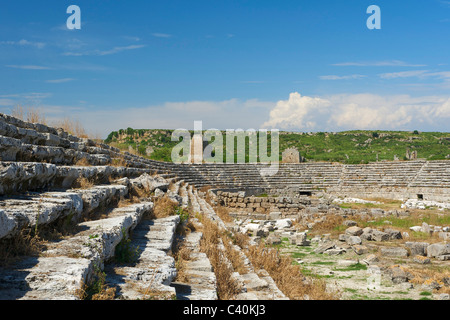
[0,0,450,137]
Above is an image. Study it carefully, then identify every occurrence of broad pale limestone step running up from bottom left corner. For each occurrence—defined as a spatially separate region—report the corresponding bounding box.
[0,202,153,300]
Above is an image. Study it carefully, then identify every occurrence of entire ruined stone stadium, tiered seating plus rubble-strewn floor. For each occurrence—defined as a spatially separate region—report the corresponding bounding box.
[0,114,450,300]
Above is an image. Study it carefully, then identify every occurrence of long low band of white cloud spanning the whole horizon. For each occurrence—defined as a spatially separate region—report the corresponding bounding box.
[0,92,450,137]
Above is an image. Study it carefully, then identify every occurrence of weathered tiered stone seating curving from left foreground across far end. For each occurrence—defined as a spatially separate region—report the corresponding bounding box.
[0,114,450,299]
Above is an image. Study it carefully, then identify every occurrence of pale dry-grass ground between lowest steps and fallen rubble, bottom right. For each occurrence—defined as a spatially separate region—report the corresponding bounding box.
[279,238,450,300]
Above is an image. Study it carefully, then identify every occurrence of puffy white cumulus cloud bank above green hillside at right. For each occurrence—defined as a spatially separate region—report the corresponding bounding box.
[263,92,450,131]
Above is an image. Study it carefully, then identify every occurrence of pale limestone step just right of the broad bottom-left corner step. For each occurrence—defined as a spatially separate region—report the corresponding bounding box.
[105,216,180,300]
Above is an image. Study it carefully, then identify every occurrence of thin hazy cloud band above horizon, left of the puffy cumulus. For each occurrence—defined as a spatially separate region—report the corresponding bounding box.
[22,96,273,138]
